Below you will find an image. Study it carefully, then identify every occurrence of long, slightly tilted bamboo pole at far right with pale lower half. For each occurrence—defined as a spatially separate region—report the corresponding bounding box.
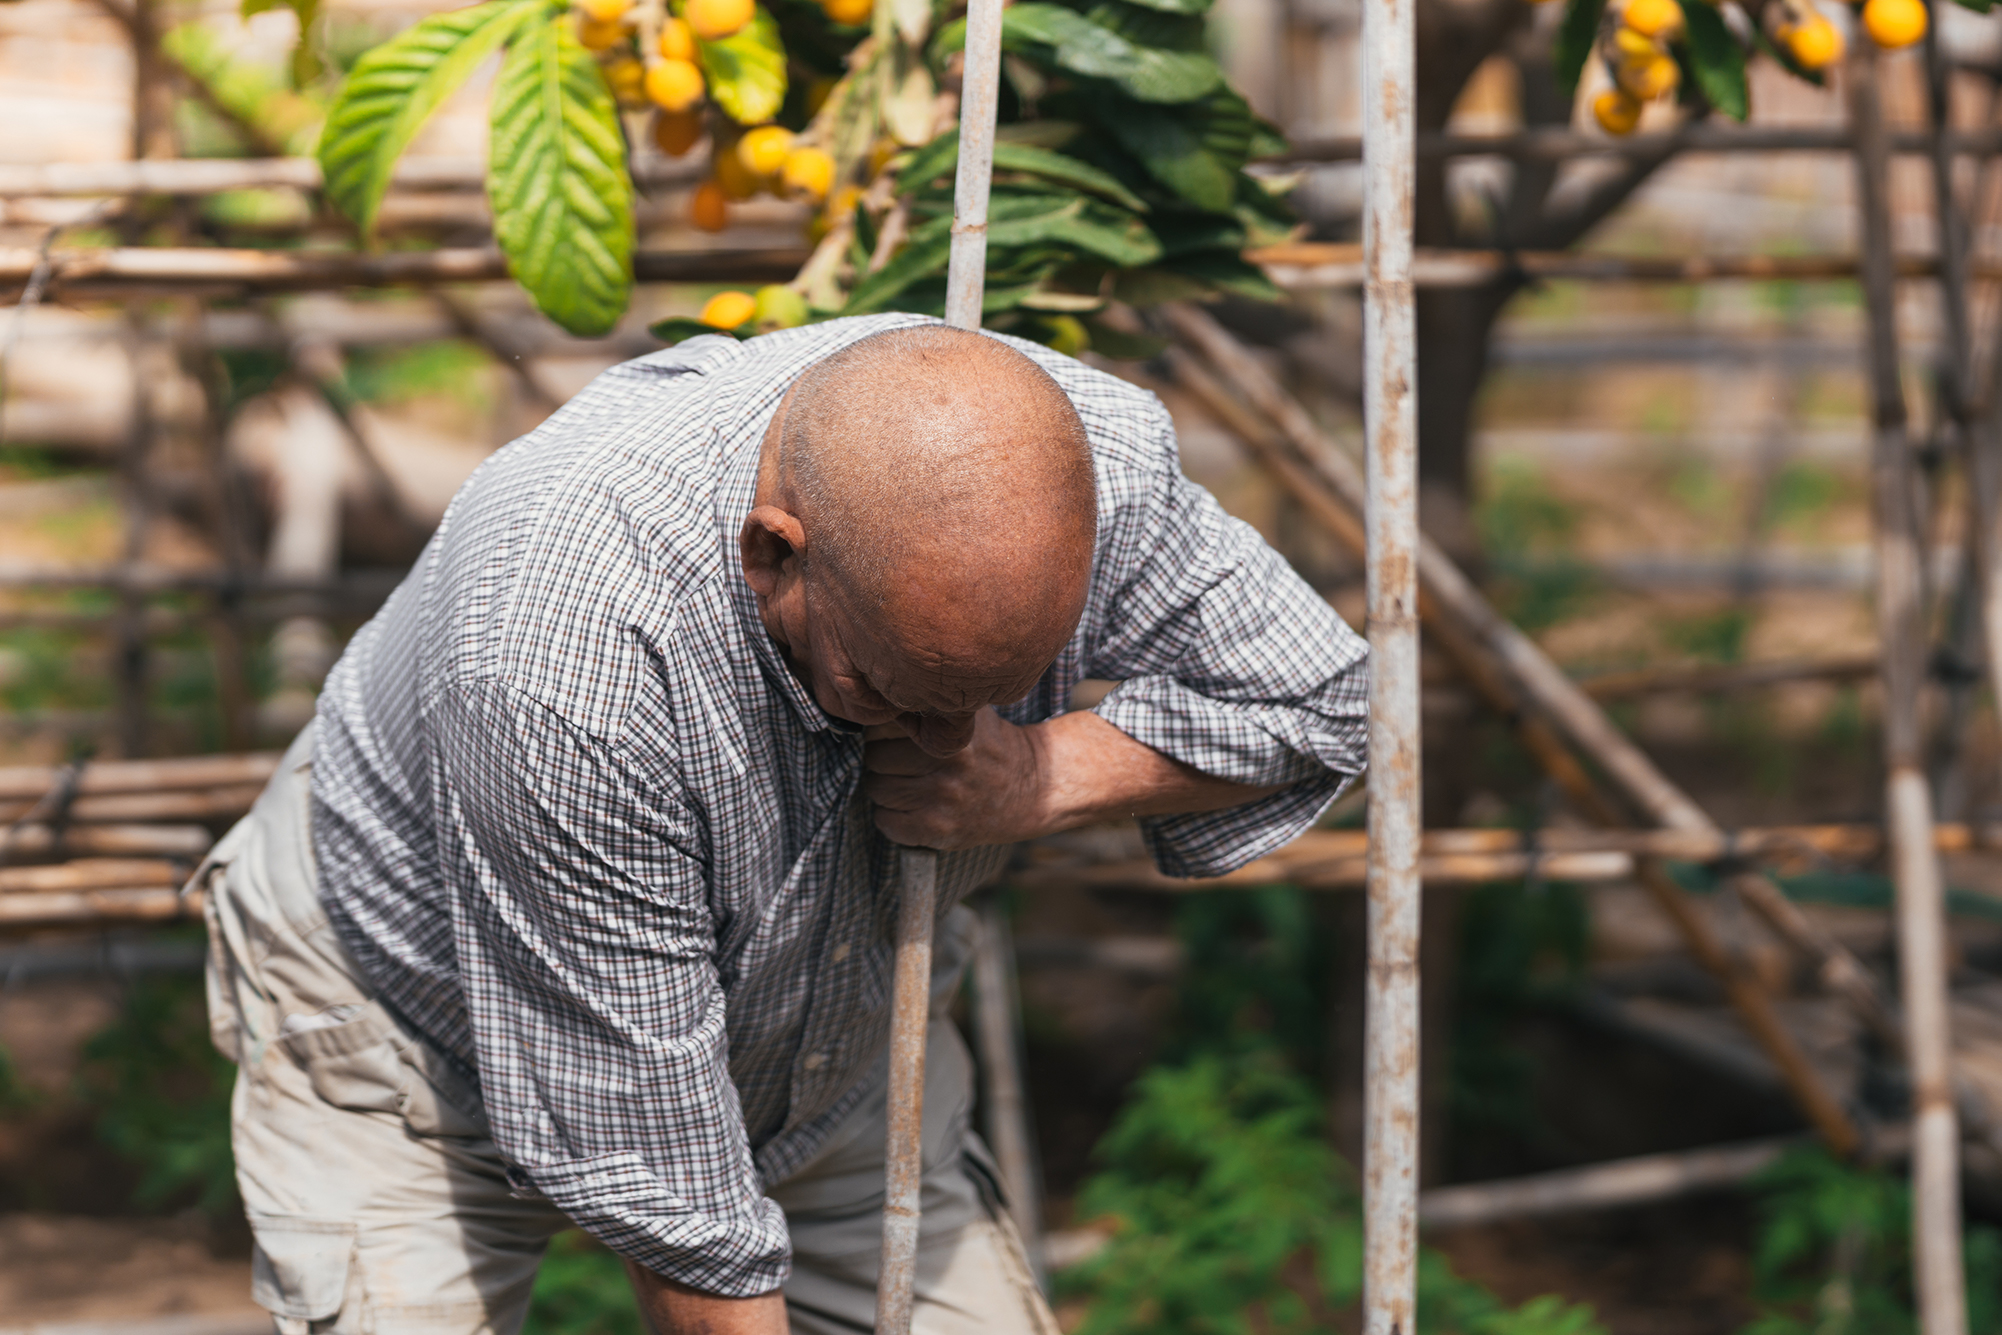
[1844,42,1968,1335]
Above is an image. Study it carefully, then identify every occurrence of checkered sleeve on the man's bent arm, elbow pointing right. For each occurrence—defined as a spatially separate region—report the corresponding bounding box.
[1085,412,1367,877]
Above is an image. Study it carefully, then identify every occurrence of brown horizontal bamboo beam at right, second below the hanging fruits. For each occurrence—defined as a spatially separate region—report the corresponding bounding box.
[1245,240,1977,290]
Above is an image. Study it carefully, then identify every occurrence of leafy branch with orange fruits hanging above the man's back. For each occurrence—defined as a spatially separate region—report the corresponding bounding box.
[318,0,1291,340]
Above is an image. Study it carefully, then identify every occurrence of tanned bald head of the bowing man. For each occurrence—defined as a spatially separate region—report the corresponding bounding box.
[745,324,1097,752]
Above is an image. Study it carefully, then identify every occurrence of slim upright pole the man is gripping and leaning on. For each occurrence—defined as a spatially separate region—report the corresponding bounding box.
[875,0,1001,1335]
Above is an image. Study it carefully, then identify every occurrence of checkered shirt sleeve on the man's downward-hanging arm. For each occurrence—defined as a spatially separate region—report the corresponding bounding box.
[430,683,791,1297]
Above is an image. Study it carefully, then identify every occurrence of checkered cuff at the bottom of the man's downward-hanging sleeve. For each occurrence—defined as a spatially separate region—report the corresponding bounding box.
[509,1153,793,1297]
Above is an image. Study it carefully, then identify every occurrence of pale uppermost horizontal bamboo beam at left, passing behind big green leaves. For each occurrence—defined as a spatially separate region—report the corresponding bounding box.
[0,154,707,198]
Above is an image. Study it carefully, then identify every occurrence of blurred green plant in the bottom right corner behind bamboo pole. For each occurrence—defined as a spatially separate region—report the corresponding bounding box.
[1742,1149,2002,1335]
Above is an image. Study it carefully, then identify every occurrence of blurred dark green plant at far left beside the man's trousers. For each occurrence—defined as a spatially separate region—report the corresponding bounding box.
[78,977,236,1213]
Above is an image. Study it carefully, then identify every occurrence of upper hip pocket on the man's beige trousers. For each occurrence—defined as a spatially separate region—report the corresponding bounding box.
[278,1001,486,1137]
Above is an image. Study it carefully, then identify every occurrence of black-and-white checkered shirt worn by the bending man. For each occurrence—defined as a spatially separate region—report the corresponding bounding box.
[312,314,1365,1295]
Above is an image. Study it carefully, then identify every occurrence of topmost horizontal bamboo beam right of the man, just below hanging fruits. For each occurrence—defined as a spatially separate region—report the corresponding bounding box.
[1263,120,2002,164]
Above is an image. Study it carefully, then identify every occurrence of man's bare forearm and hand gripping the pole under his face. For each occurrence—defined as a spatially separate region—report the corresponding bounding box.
[863,709,1277,849]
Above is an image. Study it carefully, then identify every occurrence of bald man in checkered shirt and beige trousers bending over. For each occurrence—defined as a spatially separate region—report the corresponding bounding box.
[204,316,1363,1335]
